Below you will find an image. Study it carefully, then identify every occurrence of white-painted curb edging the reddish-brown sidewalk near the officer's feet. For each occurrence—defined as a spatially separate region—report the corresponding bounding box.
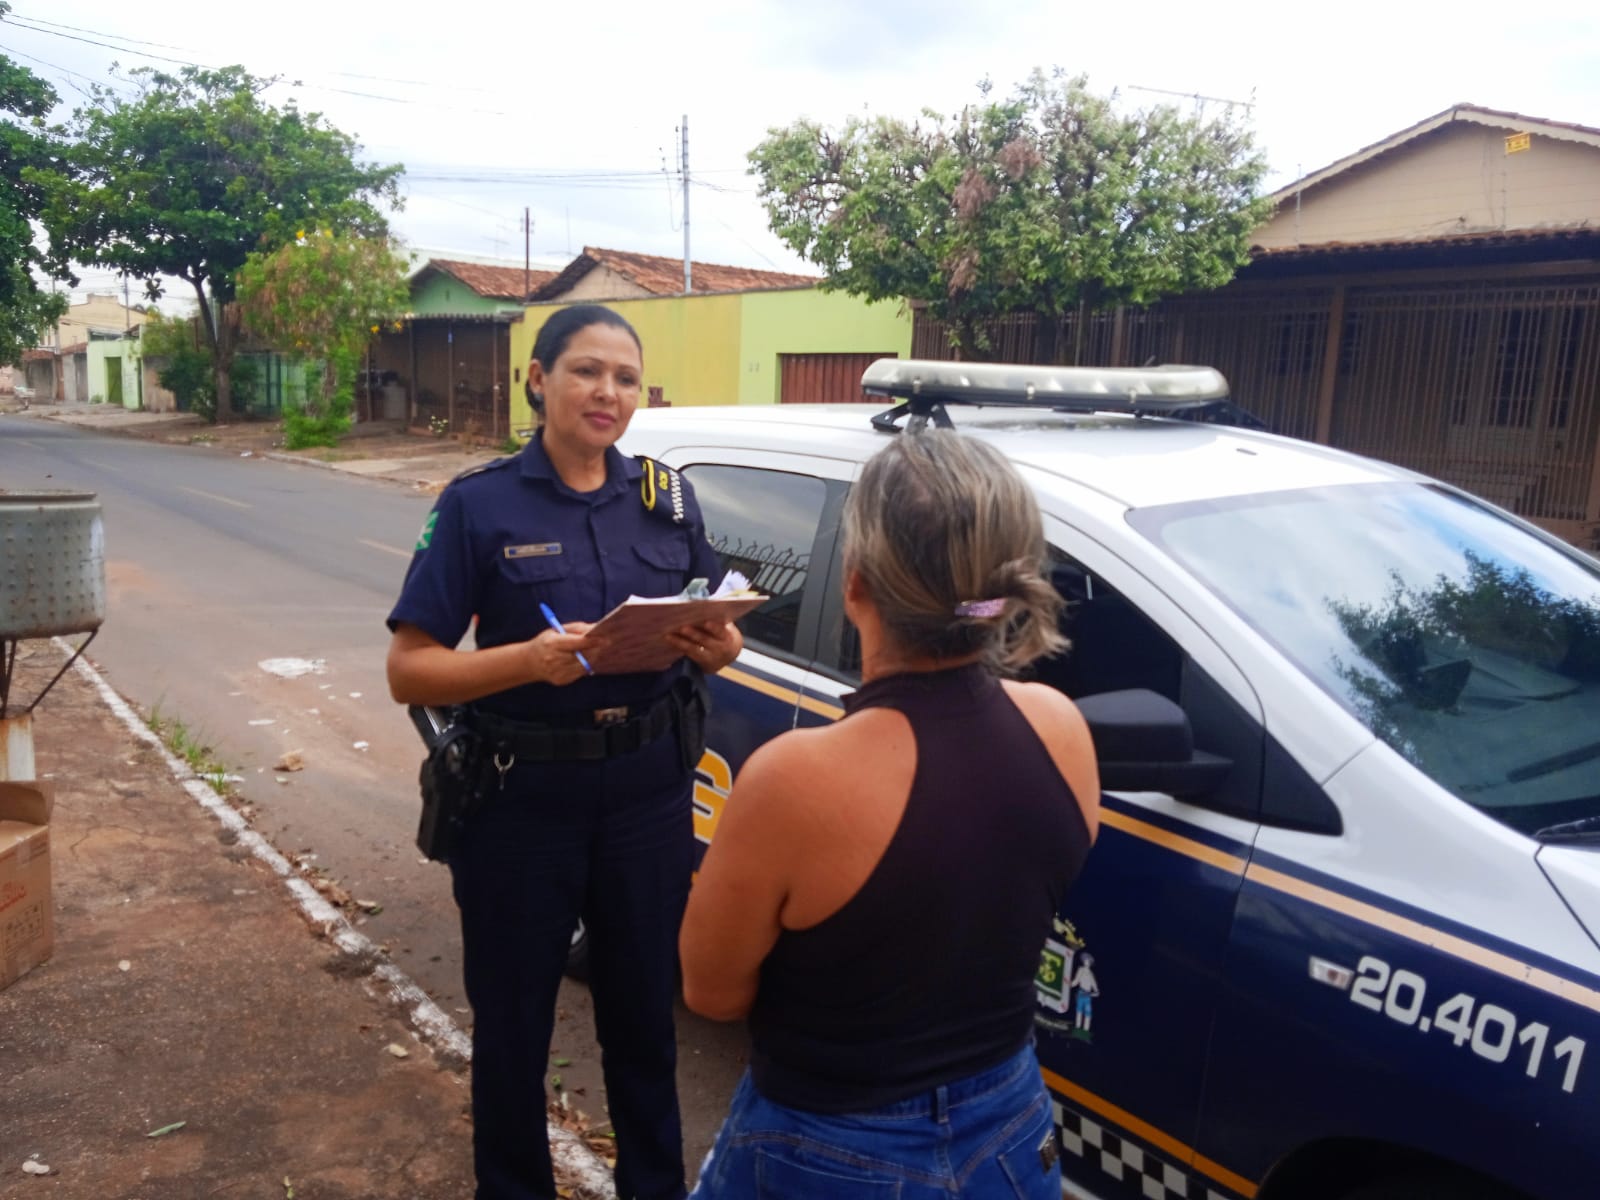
[53,637,616,1200]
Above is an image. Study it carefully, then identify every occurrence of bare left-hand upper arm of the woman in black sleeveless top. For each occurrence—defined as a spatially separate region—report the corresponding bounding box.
[678,736,805,1021]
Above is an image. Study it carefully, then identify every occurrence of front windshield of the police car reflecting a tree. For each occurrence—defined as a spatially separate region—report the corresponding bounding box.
[1130,483,1600,834]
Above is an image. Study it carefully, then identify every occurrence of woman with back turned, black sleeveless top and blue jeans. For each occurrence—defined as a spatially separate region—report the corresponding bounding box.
[680,430,1099,1200]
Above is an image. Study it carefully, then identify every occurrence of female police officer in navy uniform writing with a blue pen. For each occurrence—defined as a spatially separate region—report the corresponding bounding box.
[389,306,741,1200]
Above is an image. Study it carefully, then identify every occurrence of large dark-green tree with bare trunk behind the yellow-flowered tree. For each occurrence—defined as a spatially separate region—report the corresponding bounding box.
[35,67,402,419]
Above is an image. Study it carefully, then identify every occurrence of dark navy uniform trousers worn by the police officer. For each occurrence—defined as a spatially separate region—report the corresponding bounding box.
[451,731,694,1200]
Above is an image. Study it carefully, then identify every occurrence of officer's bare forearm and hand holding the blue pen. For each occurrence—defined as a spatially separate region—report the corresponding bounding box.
[386,621,589,704]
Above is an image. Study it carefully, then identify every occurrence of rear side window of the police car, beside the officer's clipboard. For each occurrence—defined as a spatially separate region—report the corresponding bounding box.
[683,462,827,653]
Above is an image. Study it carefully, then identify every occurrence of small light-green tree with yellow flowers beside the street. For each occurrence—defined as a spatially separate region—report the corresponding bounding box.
[237,230,411,450]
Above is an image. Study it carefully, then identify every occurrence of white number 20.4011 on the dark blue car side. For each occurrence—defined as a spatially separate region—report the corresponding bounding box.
[1350,955,1584,1091]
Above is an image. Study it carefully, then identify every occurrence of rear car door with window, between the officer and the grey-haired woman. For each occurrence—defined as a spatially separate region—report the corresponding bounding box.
[661,446,854,853]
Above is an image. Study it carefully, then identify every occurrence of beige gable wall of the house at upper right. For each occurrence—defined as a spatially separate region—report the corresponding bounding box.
[1256,123,1600,250]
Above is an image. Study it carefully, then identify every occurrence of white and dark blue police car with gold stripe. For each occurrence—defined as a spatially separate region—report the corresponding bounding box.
[624,362,1600,1200]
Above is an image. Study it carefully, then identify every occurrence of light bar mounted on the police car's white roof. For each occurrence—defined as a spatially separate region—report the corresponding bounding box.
[861,358,1234,432]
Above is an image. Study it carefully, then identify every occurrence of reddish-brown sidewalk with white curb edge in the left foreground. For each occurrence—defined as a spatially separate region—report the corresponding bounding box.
[0,620,611,1200]
